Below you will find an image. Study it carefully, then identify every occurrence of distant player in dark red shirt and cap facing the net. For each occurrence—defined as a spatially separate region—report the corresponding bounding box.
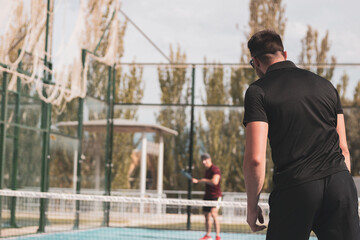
[192,153,222,240]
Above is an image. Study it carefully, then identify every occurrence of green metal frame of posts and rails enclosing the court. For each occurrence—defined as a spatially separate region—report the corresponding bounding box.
[0,0,360,236]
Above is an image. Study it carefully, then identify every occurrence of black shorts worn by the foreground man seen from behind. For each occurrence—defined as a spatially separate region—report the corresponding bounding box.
[266,171,360,240]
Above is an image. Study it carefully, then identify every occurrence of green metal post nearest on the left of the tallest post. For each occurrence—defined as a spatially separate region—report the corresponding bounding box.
[10,62,21,227]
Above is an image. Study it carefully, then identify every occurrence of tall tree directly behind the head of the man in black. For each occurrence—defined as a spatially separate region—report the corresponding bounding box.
[230,0,286,191]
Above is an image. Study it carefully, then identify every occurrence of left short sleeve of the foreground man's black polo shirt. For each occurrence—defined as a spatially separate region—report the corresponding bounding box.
[243,85,268,127]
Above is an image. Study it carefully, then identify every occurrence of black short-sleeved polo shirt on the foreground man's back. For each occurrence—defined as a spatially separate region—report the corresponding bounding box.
[244,61,347,189]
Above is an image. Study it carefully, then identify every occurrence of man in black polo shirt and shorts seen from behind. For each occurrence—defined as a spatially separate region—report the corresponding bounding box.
[243,30,360,240]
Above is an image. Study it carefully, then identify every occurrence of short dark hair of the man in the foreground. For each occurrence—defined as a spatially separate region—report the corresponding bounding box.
[248,30,284,57]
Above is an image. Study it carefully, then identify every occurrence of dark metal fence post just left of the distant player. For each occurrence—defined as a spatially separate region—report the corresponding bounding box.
[186,65,195,230]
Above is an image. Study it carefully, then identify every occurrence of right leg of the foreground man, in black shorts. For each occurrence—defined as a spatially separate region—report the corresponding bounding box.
[314,171,360,240]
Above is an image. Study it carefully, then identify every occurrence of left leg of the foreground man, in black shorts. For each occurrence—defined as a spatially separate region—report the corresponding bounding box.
[266,180,324,240]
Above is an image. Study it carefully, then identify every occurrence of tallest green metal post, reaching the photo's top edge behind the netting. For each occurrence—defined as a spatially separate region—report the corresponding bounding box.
[38,0,51,232]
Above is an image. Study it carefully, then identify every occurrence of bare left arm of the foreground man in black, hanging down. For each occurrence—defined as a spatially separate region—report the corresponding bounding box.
[243,122,268,232]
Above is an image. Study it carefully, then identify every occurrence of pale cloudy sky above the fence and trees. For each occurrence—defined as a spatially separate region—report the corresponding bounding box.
[0,0,360,102]
